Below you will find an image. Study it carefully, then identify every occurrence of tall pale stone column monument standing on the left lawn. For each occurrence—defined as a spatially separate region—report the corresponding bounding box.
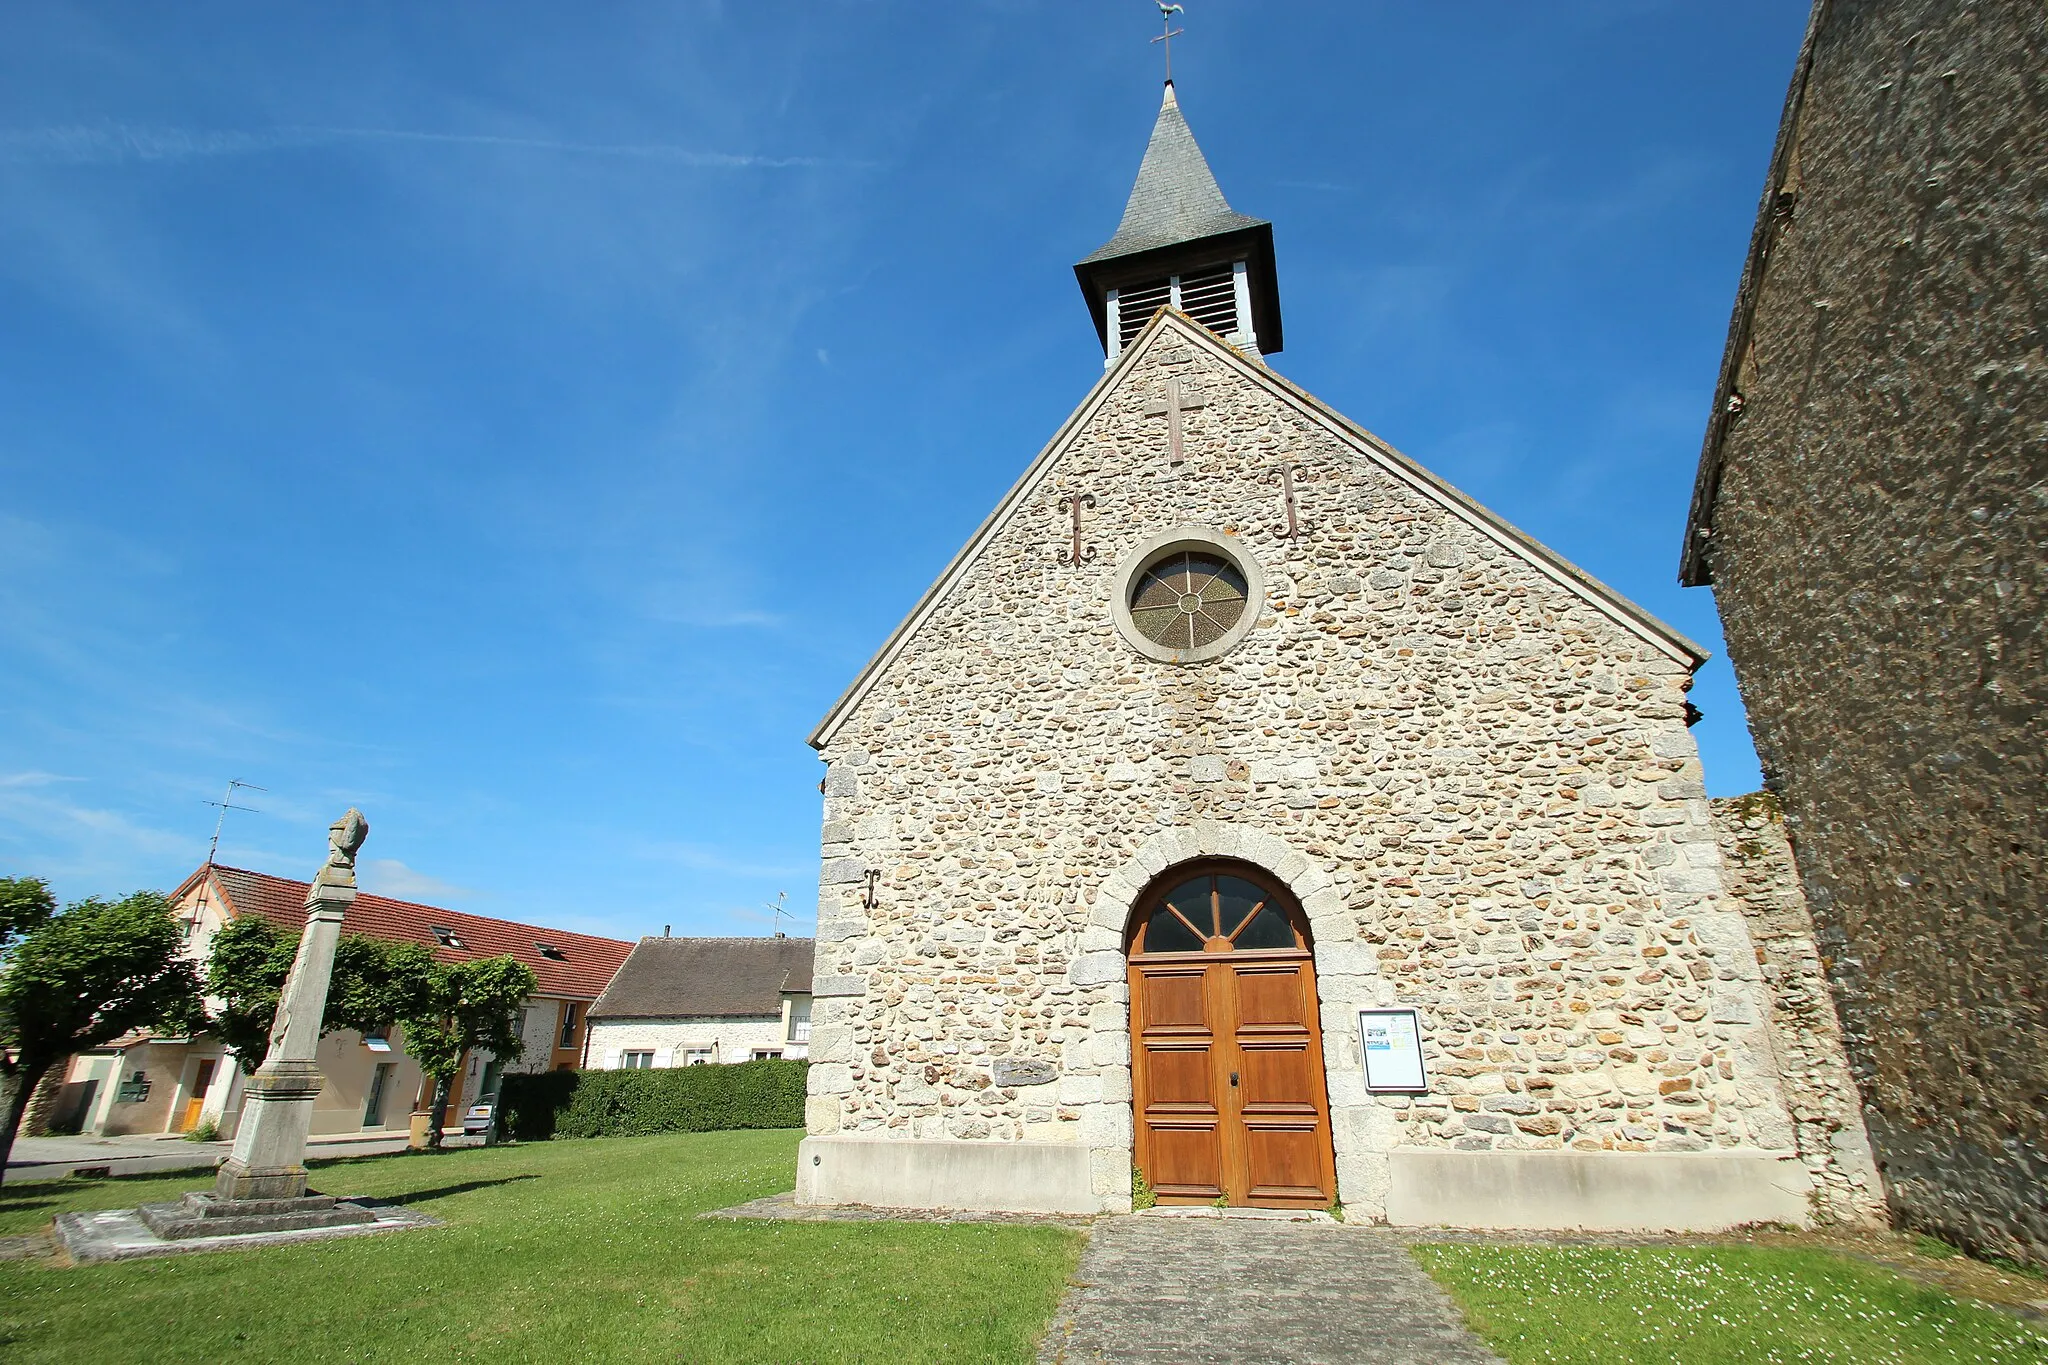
[213,808,371,1201]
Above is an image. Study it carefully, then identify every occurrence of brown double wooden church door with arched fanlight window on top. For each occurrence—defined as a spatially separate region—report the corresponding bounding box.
[1126,860,1337,1209]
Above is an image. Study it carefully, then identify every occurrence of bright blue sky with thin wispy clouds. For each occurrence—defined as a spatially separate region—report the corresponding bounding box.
[0,0,1804,937]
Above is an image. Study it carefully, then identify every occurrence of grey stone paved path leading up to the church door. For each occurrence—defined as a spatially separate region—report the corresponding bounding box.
[1038,1216,1499,1365]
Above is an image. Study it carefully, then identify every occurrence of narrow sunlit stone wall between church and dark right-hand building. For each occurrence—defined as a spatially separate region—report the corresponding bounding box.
[1712,792,1888,1224]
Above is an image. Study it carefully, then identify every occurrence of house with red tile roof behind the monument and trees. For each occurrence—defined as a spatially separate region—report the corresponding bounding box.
[59,864,633,1136]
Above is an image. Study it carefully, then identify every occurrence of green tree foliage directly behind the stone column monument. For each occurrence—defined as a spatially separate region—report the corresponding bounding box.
[207,915,434,1074]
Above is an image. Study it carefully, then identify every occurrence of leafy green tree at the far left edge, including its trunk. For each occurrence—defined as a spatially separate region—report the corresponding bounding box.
[0,878,203,1173]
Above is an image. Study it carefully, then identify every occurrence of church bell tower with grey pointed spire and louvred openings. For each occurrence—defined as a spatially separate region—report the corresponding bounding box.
[1073,80,1282,364]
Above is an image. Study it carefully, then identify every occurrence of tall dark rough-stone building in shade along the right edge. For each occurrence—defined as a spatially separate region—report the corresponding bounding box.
[1681,0,2048,1263]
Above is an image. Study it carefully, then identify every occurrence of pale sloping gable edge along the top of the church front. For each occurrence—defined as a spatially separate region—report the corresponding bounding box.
[809,309,1710,749]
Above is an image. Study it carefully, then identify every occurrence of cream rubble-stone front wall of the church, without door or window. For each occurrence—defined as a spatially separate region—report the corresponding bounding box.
[799,313,1855,1226]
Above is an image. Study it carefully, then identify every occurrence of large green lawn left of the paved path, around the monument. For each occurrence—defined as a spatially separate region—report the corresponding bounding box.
[0,1132,1081,1365]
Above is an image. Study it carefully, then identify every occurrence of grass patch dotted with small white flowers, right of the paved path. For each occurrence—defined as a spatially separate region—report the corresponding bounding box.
[1415,1244,2048,1365]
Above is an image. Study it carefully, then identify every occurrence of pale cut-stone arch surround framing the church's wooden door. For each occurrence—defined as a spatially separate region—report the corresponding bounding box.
[1071,821,1395,1216]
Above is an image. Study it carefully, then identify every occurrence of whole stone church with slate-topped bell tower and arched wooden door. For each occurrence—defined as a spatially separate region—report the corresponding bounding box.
[799,84,1876,1228]
